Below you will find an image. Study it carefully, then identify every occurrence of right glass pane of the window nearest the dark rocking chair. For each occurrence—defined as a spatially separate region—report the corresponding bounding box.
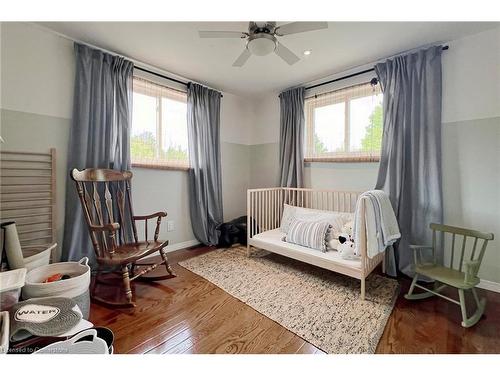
[161,98,188,162]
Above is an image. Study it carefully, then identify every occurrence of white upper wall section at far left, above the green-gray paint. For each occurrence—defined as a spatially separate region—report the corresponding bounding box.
[1,22,75,118]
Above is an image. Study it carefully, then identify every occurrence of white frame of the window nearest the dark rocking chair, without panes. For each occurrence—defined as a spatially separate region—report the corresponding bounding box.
[130,75,191,171]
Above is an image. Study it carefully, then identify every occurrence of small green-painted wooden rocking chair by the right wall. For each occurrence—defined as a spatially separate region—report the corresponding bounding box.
[405,223,493,328]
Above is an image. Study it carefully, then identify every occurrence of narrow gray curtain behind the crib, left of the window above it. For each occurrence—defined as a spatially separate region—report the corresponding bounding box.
[279,87,305,187]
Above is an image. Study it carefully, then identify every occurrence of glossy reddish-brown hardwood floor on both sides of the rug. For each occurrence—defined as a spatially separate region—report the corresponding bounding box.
[90,247,500,353]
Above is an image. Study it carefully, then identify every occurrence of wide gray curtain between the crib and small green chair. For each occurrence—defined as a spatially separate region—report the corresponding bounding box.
[375,46,443,276]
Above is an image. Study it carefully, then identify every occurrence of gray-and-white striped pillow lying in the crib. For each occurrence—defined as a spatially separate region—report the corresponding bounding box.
[285,220,332,253]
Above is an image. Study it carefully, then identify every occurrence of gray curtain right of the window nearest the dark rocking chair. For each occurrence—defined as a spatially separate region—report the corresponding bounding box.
[187,83,223,245]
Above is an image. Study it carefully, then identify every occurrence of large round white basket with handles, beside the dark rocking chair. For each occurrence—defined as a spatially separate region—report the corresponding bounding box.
[22,257,90,319]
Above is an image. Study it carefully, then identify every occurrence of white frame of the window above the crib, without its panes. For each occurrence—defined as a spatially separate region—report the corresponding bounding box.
[304,82,383,163]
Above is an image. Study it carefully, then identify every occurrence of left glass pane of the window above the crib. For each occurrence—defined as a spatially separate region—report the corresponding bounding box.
[313,103,345,155]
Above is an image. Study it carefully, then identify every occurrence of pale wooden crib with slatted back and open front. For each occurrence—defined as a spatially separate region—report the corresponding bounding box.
[247,187,384,299]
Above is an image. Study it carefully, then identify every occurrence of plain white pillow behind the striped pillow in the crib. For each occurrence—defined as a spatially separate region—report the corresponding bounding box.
[280,204,354,238]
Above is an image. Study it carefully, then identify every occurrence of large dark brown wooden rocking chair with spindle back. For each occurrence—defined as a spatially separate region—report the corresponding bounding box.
[71,169,175,307]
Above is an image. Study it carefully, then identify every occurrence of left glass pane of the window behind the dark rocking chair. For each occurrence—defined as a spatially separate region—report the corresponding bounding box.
[130,93,157,159]
